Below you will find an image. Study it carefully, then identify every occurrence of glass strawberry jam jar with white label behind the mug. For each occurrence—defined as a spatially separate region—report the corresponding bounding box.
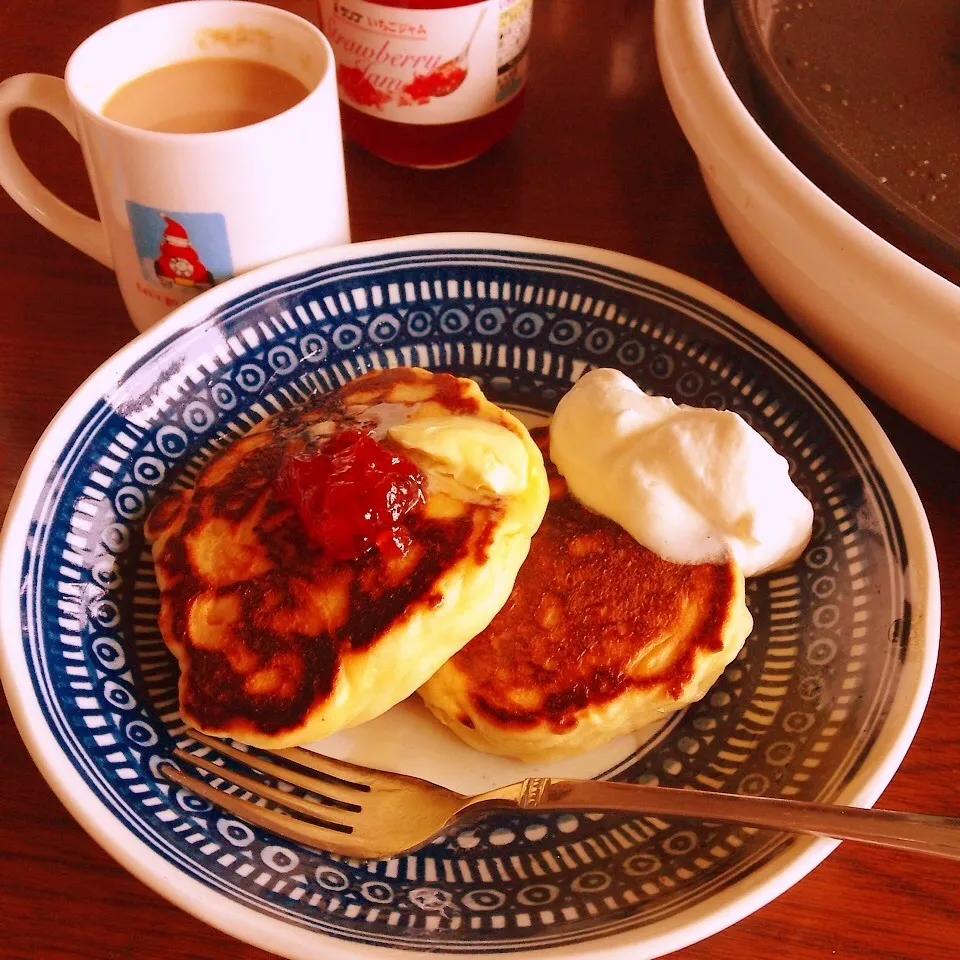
[318,0,533,169]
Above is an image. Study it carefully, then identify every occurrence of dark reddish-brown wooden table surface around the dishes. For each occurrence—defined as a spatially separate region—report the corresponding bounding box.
[0,0,960,960]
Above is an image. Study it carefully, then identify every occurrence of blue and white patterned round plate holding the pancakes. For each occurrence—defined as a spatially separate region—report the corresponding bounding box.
[0,234,939,960]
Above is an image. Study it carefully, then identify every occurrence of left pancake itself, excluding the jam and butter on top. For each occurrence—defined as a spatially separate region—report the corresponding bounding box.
[147,368,547,747]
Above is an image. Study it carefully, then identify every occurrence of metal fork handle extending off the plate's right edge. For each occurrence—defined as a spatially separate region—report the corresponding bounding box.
[519,777,960,860]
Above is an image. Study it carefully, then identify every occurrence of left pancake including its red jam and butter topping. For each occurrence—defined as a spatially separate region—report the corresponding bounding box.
[146,368,548,748]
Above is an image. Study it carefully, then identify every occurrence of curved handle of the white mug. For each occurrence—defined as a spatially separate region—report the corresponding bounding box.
[0,73,113,267]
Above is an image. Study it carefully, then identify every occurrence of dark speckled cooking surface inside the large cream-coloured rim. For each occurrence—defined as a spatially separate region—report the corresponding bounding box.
[720,0,960,284]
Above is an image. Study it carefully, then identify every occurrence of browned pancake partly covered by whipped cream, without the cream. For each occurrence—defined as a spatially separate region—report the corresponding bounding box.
[420,428,753,760]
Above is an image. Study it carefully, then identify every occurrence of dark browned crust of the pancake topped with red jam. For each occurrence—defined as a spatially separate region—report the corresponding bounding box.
[147,368,502,735]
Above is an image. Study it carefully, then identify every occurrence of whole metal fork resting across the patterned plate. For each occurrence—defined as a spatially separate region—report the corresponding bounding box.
[163,730,960,860]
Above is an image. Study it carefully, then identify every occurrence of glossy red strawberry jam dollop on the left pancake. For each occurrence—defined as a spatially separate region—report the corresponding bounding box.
[277,428,426,560]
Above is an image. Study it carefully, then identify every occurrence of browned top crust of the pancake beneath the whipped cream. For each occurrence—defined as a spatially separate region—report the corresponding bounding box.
[452,427,737,732]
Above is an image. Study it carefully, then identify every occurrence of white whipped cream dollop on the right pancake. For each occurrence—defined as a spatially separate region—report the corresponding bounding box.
[550,369,813,577]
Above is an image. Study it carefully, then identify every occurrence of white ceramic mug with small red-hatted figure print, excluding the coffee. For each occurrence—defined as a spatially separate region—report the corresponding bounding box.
[0,0,350,330]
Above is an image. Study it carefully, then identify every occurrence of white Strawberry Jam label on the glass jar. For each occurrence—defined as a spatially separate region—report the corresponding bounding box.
[320,0,533,124]
